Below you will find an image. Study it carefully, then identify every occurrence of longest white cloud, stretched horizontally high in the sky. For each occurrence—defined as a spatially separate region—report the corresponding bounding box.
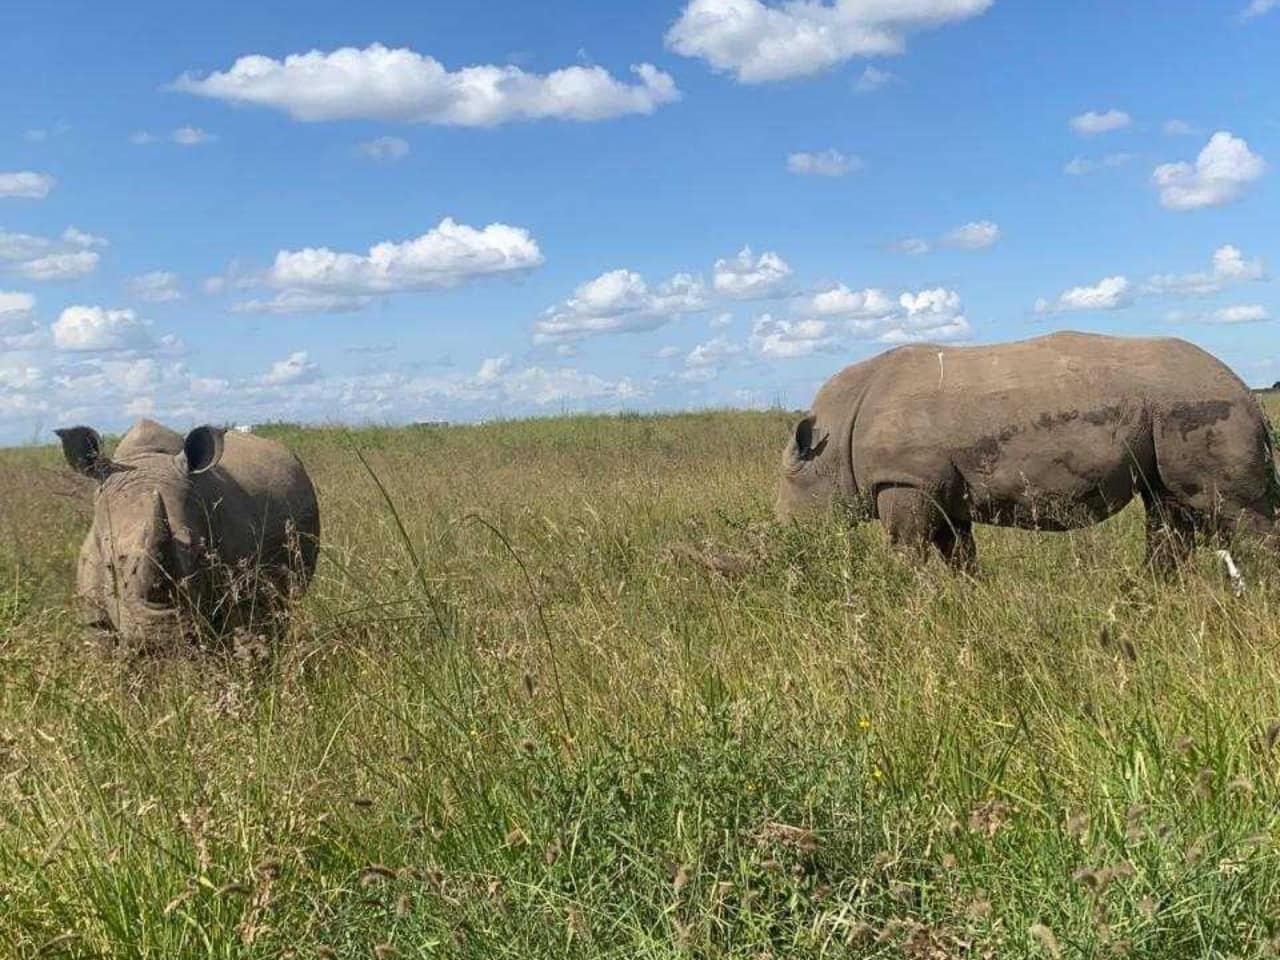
[173,44,680,127]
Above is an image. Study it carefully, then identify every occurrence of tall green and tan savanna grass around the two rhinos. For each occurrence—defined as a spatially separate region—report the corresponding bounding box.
[0,394,1280,960]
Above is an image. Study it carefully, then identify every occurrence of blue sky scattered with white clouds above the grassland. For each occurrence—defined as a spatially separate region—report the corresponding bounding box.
[0,0,1280,443]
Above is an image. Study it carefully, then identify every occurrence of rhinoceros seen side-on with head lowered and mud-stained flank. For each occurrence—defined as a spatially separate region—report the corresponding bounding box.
[778,333,1280,571]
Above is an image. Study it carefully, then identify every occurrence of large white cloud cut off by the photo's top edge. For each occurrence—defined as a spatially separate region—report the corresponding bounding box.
[666,0,992,83]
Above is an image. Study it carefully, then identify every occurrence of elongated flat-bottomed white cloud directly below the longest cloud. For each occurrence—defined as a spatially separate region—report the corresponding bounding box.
[266,218,543,296]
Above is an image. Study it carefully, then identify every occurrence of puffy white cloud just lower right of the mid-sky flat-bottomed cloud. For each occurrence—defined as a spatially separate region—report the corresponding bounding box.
[534,270,708,343]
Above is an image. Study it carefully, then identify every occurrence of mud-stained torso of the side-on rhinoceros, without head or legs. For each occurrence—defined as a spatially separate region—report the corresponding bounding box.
[824,333,1274,526]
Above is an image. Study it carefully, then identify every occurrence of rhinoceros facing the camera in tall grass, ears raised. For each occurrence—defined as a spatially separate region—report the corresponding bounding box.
[58,420,320,646]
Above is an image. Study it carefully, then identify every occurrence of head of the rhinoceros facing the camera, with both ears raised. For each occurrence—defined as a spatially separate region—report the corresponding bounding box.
[56,426,223,643]
